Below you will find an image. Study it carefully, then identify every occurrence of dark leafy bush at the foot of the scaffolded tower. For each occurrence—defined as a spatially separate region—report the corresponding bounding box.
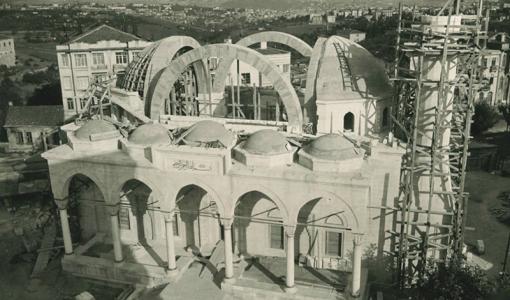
[416,258,496,300]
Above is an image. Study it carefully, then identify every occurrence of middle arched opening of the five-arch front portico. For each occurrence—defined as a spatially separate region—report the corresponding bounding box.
[174,184,222,256]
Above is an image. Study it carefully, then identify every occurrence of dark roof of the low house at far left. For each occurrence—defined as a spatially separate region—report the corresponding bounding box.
[4,105,64,127]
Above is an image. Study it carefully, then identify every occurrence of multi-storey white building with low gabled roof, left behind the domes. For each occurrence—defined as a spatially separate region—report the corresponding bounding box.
[57,25,151,119]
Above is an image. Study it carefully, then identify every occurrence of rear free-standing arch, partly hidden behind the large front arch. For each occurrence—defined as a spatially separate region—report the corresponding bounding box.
[213,31,312,93]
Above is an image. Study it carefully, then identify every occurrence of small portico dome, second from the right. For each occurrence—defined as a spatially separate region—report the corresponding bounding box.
[243,129,291,154]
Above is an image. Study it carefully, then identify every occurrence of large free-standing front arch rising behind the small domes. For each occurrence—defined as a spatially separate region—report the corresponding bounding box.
[146,44,303,133]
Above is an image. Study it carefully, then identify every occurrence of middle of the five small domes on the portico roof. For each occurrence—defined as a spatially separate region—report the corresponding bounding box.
[184,120,234,147]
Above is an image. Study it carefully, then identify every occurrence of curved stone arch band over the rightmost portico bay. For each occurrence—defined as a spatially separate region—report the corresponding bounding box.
[290,191,361,233]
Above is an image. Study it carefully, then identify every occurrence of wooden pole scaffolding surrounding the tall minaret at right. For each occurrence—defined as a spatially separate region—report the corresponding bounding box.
[389,0,488,289]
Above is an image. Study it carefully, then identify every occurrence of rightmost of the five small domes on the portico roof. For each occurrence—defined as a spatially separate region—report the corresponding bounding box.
[304,133,360,160]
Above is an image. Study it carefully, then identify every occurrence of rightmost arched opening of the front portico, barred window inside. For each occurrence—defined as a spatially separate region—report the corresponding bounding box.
[294,197,352,291]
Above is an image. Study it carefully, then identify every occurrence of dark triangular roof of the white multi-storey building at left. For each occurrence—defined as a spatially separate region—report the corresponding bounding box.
[69,24,143,44]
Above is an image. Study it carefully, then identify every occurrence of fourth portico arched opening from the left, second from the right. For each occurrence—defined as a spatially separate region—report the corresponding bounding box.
[233,191,286,284]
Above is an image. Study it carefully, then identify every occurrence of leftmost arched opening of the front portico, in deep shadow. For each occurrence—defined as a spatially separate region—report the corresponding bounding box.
[68,174,106,241]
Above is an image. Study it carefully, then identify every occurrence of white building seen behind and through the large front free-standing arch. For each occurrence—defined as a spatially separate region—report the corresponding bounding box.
[225,42,290,87]
